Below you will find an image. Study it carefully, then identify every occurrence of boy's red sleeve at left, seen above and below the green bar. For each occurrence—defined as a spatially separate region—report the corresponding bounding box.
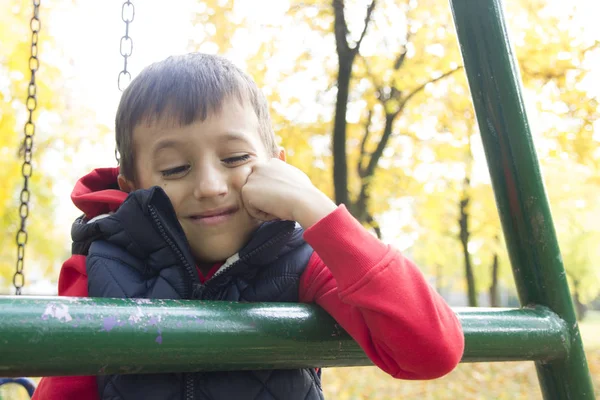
[32,256,100,400]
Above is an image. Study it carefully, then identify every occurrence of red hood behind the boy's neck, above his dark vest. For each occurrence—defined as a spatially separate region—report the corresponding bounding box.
[71,167,127,218]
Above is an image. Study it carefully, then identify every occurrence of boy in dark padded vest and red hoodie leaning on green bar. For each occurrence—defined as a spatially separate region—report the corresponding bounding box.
[34,54,464,400]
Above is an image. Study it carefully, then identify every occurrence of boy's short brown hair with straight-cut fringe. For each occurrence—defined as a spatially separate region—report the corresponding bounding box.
[115,53,278,181]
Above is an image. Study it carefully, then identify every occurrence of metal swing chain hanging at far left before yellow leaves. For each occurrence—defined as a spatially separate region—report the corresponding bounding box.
[13,0,42,295]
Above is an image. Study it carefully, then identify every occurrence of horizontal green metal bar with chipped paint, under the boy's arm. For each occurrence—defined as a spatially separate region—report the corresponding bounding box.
[0,296,569,376]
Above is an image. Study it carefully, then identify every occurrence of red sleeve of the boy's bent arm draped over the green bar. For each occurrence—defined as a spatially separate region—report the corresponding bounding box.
[300,206,464,379]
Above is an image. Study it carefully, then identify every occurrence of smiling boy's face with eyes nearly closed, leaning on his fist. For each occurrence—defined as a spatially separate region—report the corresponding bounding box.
[119,100,282,263]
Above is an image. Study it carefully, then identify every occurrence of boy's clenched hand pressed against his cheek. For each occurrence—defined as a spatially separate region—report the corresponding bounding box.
[242,158,337,229]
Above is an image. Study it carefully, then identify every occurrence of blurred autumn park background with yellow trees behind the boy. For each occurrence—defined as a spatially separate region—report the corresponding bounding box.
[0,0,600,399]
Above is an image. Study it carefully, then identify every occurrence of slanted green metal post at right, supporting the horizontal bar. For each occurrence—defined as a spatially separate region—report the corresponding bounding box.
[450,0,594,400]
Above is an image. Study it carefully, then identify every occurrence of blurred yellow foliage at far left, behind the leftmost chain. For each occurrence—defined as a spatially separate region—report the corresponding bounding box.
[0,0,68,290]
